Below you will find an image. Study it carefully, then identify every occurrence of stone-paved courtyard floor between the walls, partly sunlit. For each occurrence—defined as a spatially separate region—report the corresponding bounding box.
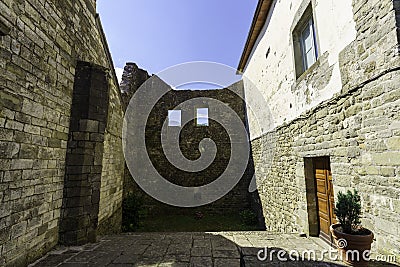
[30,232,395,267]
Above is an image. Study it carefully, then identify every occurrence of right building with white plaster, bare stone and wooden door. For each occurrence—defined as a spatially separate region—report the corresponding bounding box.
[238,0,400,255]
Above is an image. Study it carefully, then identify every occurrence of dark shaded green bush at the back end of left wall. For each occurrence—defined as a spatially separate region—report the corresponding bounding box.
[122,193,146,232]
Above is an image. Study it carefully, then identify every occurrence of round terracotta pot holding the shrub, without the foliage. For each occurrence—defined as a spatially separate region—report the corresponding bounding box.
[330,224,374,267]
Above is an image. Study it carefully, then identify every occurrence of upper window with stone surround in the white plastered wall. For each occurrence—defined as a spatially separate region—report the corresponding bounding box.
[293,5,318,78]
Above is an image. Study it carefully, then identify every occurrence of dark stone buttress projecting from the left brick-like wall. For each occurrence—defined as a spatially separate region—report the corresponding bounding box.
[60,63,109,245]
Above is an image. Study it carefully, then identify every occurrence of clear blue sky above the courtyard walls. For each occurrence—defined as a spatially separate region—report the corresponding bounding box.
[97,0,258,80]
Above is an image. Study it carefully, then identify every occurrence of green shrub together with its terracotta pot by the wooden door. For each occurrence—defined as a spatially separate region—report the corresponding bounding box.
[330,190,374,266]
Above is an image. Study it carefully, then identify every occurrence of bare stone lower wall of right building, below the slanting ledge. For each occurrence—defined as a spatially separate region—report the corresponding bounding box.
[252,71,400,249]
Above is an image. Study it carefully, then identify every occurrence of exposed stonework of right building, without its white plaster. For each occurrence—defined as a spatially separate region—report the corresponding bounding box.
[245,0,400,255]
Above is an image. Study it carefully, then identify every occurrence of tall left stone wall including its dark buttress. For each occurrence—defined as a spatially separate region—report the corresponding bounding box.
[0,0,124,266]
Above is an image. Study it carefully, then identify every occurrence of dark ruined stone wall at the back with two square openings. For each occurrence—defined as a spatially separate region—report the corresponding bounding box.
[121,63,253,216]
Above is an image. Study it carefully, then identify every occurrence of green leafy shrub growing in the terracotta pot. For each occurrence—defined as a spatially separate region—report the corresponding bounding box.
[334,190,361,234]
